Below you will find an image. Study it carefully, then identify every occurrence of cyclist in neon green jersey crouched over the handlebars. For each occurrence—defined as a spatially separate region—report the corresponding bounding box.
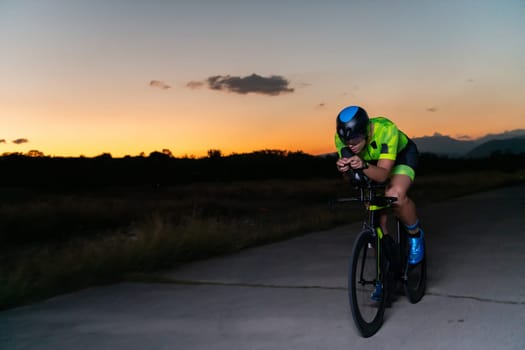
[335,106,425,270]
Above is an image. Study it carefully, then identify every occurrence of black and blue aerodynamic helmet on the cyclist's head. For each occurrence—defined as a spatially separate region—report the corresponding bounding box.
[336,106,369,142]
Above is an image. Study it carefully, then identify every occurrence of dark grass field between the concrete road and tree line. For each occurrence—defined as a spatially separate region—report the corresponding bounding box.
[0,171,525,309]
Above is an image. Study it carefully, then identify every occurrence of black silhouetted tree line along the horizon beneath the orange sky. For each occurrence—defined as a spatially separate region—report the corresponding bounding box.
[0,149,525,187]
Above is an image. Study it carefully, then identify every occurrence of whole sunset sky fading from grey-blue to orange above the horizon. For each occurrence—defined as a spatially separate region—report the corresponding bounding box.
[0,0,525,157]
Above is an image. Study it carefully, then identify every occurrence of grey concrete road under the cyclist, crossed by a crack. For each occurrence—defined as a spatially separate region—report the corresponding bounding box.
[0,184,525,350]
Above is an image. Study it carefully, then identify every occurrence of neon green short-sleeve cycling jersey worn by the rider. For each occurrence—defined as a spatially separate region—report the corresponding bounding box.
[335,117,408,161]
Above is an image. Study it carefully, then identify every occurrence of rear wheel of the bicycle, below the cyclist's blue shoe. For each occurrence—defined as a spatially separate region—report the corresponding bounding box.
[403,233,427,304]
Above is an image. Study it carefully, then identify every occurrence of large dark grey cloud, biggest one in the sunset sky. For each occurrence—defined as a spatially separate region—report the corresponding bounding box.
[186,74,294,96]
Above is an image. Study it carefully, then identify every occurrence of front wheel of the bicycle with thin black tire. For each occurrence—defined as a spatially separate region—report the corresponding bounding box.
[348,230,386,337]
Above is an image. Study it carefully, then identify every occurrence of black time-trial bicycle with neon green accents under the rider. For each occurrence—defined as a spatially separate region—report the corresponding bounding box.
[337,170,427,337]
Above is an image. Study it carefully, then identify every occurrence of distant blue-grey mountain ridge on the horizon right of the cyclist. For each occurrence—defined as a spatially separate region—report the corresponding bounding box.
[413,129,525,157]
